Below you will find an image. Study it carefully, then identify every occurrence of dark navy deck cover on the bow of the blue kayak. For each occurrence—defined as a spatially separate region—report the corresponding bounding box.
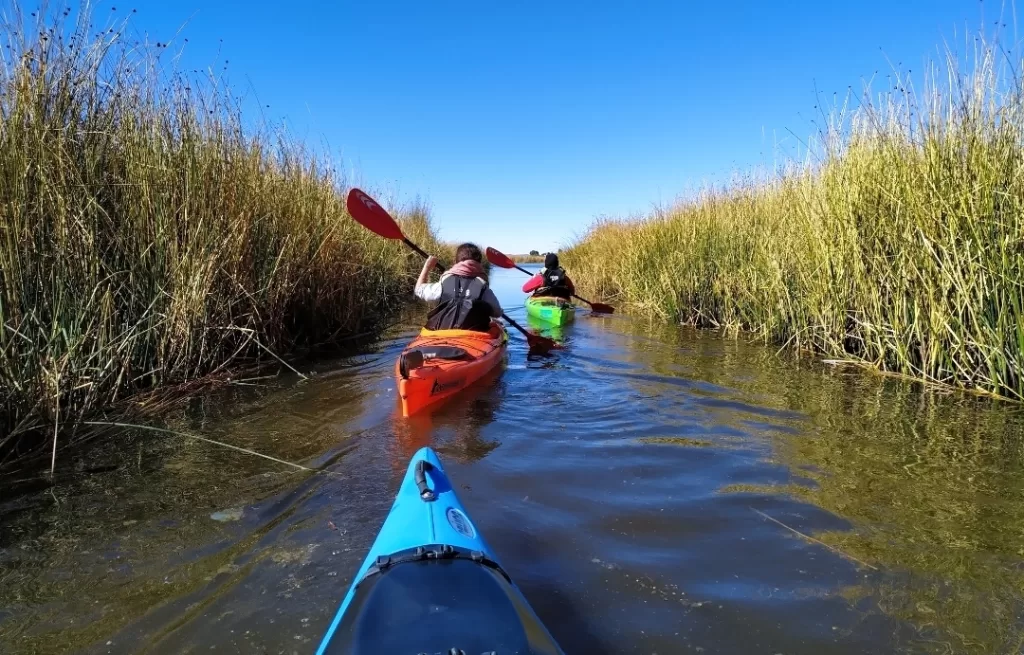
[324,557,561,655]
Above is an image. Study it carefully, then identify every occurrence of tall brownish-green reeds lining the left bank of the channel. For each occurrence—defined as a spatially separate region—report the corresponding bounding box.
[0,2,438,466]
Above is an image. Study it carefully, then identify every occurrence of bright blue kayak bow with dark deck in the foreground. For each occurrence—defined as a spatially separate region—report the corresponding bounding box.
[316,448,564,655]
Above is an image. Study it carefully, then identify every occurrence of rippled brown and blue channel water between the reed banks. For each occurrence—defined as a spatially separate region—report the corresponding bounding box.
[0,270,1024,655]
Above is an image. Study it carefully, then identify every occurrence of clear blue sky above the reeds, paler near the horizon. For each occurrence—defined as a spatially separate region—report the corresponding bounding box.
[96,0,1013,252]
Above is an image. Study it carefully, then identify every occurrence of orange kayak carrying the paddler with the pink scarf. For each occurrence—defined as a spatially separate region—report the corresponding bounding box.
[394,322,508,417]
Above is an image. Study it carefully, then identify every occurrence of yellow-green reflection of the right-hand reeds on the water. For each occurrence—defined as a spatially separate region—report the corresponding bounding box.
[609,320,1024,655]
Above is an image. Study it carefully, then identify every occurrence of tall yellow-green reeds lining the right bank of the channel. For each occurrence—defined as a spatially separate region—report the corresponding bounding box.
[562,26,1024,400]
